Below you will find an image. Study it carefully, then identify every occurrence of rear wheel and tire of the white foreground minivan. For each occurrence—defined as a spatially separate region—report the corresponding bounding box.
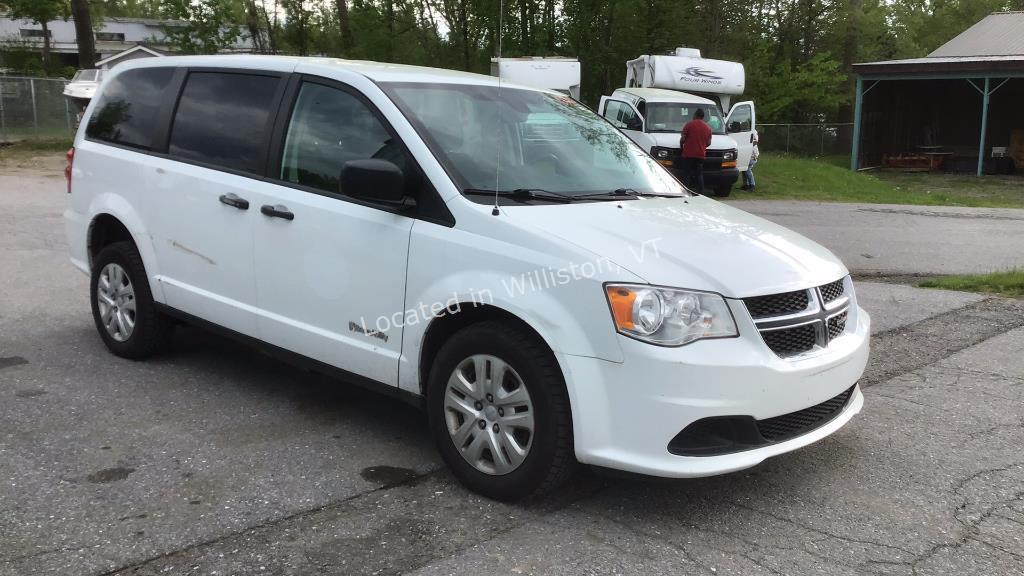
[90,242,174,360]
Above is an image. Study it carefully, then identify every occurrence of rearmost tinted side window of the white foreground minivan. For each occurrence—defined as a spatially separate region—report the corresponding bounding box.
[85,68,174,150]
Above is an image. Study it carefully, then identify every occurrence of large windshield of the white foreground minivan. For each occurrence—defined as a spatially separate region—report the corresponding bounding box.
[383,83,686,197]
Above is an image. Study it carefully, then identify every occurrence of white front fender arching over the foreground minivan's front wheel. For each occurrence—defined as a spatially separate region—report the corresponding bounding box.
[398,212,639,393]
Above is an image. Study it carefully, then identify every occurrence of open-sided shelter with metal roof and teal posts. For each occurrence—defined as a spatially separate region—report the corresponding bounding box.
[850,12,1024,176]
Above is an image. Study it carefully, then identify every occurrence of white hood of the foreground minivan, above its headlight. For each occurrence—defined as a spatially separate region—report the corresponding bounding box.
[505,196,848,298]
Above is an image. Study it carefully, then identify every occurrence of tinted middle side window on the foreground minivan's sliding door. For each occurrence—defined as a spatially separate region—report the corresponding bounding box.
[168,72,280,174]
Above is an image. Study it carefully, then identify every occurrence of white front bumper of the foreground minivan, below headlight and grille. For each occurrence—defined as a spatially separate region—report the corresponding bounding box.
[561,302,870,478]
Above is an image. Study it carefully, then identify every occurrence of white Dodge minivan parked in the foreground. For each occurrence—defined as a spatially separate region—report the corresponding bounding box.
[65,55,869,499]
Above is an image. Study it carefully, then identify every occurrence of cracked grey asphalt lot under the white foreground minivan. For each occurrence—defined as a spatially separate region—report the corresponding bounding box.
[6,159,1024,576]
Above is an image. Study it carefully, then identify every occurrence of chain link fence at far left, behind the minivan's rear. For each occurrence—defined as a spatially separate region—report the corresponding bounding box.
[0,76,77,143]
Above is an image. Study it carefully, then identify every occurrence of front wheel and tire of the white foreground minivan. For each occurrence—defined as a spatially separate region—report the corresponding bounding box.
[427,322,577,500]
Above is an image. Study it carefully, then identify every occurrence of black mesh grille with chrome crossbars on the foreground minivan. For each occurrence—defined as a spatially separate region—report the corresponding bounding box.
[743,278,850,358]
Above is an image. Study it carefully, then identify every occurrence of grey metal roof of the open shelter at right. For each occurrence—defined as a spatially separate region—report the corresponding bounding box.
[853,11,1024,76]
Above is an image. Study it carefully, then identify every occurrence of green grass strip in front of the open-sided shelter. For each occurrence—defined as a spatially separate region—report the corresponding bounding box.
[733,154,1024,208]
